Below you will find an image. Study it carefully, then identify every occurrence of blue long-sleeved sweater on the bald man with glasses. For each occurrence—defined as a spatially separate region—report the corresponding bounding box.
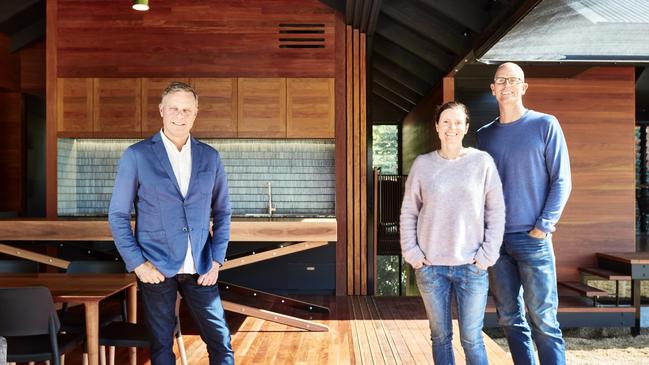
[477,110,572,233]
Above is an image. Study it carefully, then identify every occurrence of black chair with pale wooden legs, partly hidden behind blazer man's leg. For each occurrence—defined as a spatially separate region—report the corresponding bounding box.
[99,296,187,365]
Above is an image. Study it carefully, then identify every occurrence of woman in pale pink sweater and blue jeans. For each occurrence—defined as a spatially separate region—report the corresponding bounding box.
[401,102,505,365]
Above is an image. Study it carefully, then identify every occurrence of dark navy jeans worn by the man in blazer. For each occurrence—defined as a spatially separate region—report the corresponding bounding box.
[138,274,234,365]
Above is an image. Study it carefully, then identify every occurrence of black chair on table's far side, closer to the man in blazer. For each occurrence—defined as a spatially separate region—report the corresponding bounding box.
[59,261,128,332]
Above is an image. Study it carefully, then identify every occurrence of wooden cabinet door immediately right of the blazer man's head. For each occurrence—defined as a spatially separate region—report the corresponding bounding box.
[191,78,237,138]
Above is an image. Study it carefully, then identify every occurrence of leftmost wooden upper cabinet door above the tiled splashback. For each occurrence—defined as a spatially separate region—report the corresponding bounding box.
[56,78,93,137]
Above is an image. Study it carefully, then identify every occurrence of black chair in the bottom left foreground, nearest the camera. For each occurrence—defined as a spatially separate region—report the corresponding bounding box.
[0,287,84,365]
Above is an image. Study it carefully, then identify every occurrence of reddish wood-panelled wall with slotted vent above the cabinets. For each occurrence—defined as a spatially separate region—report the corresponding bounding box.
[52,0,335,77]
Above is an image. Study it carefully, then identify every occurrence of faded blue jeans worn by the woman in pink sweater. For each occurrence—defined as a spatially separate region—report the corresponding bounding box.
[415,264,489,365]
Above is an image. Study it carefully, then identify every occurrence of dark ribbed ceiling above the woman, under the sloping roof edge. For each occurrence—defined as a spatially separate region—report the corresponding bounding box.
[321,0,540,123]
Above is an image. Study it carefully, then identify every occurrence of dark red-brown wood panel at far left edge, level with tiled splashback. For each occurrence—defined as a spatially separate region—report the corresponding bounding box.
[0,92,26,215]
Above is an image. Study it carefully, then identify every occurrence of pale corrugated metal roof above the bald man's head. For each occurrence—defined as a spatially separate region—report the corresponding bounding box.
[480,0,649,64]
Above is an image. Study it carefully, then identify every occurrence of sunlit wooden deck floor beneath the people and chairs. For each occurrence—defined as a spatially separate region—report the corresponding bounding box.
[66,296,512,365]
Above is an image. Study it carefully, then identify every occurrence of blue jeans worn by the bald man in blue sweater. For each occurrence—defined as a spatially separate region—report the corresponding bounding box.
[489,232,566,365]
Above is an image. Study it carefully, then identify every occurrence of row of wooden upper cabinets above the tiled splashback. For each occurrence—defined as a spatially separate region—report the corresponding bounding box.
[57,78,335,138]
